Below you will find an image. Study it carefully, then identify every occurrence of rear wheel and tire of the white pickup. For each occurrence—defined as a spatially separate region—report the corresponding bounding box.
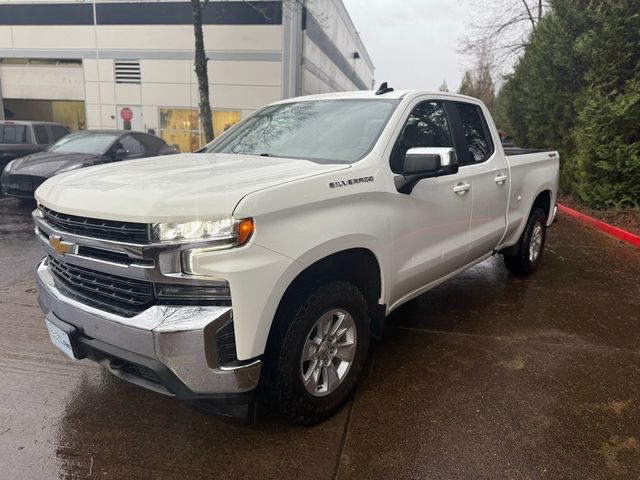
[504,208,547,275]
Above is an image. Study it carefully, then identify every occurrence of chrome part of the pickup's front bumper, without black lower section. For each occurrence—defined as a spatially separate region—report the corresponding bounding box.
[36,259,262,395]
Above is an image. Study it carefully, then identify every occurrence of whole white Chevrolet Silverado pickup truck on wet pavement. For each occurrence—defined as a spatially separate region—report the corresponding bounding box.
[33,88,559,424]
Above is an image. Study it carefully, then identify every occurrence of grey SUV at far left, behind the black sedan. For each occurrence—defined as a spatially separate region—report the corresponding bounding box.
[0,120,69,172]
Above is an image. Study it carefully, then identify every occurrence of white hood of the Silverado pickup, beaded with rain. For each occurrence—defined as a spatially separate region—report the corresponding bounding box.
[35,153,350,223]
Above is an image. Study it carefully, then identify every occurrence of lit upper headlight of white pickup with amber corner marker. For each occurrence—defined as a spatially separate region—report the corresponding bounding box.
[151,217,254,247]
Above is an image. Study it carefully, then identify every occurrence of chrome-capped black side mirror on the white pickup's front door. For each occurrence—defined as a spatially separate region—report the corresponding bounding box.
[394,147,458,194]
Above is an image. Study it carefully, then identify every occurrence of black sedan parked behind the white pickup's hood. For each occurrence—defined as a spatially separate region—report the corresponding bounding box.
[0,130,176,199]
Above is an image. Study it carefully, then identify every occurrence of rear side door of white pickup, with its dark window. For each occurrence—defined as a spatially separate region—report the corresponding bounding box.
[449,102,509,263]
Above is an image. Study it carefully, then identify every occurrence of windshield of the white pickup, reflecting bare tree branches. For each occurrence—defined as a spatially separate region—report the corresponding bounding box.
[206,99,400,163]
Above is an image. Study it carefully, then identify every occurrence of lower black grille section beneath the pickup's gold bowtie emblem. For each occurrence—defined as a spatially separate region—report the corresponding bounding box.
[49,257,154,317]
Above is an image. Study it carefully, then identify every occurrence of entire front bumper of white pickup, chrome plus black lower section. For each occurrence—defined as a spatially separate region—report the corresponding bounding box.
[36,258,262,403]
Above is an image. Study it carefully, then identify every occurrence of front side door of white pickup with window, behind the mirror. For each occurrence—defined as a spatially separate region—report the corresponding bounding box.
[389,99,471,305]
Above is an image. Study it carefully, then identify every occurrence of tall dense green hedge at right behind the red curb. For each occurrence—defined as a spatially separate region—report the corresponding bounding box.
[495,0,640,208]
